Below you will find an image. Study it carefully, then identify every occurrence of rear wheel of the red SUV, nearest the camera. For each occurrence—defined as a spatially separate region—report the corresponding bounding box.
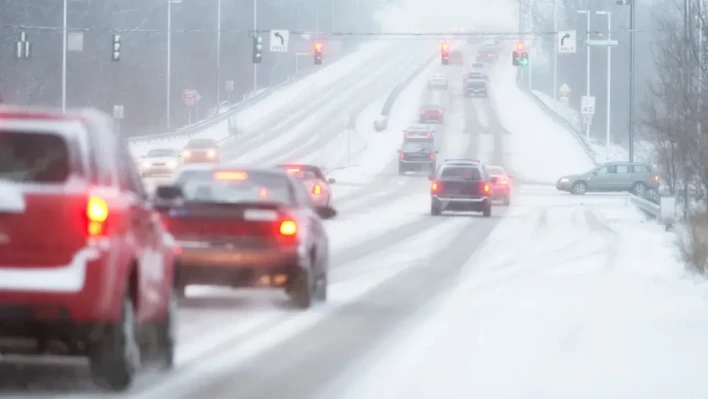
[89,295,140,392]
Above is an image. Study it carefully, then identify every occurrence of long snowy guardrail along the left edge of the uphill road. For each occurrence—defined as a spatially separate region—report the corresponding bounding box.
[126,49,356,144]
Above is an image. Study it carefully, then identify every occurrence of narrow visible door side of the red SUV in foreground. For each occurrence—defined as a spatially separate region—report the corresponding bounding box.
[115,141,167,322]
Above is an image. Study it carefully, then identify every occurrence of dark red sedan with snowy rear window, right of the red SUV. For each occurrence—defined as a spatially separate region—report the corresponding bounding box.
[155,165,336,309]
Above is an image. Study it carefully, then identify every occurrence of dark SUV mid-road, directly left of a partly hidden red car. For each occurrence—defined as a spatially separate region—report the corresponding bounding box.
[430,160,492,217]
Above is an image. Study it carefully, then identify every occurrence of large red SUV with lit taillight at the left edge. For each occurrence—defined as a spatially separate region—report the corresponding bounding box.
[0,106,177,391]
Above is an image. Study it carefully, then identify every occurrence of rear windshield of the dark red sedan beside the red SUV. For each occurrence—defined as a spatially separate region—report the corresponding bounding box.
[175,170,292,204]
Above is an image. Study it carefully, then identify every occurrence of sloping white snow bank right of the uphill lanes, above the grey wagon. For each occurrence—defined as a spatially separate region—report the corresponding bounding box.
[490,64,593,183]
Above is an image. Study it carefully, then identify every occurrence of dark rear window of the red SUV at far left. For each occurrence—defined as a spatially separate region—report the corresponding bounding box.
[0,131,73,184]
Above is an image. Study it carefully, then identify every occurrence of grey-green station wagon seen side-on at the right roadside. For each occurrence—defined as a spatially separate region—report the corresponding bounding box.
[556,162,660,196]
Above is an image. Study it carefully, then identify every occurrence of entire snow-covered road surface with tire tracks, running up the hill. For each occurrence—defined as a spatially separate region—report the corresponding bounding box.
[0,37,708,399]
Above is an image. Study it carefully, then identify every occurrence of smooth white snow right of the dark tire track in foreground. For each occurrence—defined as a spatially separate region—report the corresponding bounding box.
[330,187,708,399]
